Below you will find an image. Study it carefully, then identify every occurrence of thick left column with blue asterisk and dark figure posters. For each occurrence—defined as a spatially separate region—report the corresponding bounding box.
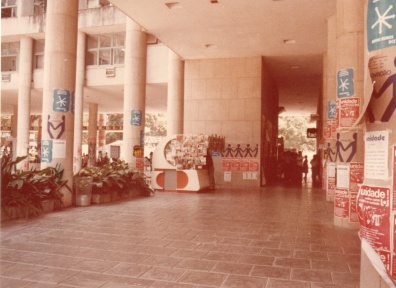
[41,0,78,206]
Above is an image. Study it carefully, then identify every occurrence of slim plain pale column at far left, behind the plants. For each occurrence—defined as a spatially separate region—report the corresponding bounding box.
[16,36,33,170]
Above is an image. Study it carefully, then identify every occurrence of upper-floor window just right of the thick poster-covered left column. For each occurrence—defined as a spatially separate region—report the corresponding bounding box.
[85,33,125,65]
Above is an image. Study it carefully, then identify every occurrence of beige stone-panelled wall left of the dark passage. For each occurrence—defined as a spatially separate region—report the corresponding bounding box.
[184,57,270,186]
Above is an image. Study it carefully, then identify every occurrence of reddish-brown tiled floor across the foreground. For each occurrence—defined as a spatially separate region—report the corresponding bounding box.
[0,184,360,288]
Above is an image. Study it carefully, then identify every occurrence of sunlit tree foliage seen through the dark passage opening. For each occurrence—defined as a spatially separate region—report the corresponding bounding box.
[278,116,316,152]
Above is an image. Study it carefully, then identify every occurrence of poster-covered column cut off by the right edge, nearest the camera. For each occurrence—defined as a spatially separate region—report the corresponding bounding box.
[357,0,396,287]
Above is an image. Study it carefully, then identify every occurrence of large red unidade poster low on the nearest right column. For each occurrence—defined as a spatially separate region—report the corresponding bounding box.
[357,185,391,253]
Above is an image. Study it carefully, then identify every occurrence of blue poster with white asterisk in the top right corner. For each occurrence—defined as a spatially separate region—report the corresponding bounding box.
[366,0,396,51]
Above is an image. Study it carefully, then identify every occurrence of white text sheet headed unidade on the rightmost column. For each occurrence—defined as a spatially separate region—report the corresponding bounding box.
[364,131,389,180]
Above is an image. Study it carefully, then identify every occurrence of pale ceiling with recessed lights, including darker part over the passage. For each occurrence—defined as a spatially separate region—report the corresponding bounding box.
[110,0,336,115]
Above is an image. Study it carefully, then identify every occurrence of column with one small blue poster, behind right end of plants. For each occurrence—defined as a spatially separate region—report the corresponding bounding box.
[121,17,147,168]
